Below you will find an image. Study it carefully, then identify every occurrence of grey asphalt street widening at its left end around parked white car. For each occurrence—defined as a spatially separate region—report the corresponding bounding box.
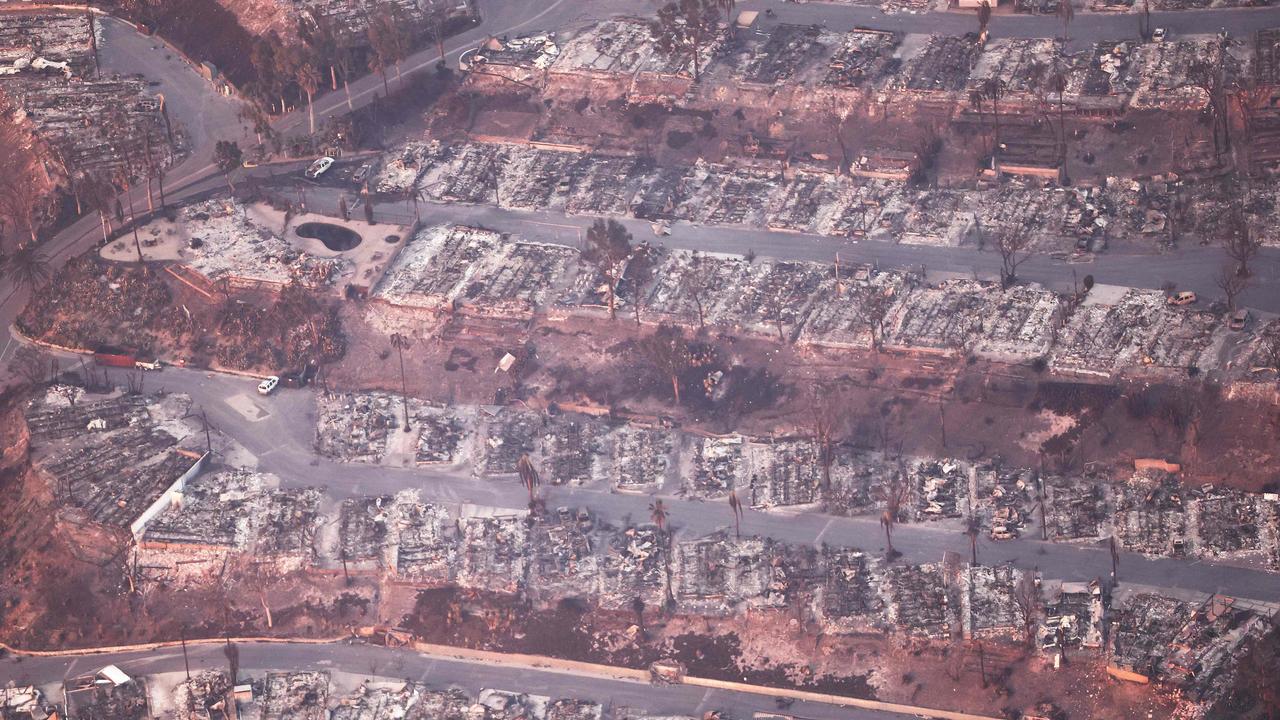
[115,368,1280,602]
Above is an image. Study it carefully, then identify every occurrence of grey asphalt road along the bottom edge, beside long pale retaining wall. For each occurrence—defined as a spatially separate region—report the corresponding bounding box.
[0,635,901,720]
